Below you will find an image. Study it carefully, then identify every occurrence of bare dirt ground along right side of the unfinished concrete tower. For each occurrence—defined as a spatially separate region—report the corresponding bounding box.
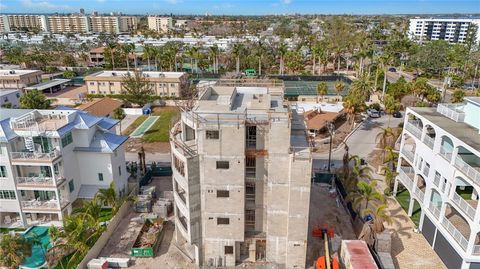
[307,183,356,268]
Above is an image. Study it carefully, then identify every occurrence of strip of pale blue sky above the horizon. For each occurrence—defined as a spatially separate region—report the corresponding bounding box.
[0,0,480,15]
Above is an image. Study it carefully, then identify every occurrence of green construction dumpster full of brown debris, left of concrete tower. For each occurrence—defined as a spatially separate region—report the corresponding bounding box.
[131,219,164,257]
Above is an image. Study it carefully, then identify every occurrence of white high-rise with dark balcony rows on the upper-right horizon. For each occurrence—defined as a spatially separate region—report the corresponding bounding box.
[408,19,480,43]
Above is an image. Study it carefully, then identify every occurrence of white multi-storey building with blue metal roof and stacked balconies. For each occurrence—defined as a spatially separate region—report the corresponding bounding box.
[0,108,128,228]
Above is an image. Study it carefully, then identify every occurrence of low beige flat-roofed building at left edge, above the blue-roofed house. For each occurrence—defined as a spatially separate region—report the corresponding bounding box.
[0,70,43,89]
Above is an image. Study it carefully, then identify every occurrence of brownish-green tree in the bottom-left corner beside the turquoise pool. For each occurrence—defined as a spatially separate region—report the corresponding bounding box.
[0,231,32,269]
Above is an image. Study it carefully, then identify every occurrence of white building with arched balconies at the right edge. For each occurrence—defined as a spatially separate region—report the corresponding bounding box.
[395,97,480,269]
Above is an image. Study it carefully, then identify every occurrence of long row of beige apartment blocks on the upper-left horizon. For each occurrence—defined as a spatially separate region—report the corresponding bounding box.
[0,14,138,34]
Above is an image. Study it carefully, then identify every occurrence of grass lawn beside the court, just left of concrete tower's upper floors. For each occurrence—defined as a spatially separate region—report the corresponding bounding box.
[142,107,180,143]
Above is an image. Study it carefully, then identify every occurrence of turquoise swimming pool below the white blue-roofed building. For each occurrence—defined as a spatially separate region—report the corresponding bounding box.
[20,226,51,269]
